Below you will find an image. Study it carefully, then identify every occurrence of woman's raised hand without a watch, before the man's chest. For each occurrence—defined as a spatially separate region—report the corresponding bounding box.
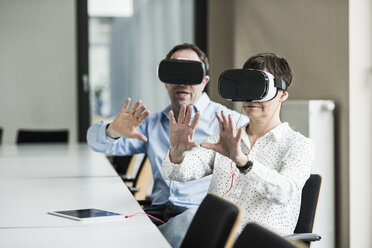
[169,104,200,164]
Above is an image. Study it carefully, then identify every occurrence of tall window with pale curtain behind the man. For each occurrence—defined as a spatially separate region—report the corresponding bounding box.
[88,0,195,123]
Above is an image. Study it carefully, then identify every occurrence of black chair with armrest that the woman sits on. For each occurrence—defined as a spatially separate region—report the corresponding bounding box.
[287,174,322,247]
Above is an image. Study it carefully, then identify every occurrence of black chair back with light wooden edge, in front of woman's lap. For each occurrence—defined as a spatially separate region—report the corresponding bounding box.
[181,194,240,248]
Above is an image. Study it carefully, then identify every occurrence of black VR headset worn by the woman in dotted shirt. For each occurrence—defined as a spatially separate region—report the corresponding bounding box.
[218,69,269,101]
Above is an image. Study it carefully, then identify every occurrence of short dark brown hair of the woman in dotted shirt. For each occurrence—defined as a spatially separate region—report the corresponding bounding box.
[243,53,293,86]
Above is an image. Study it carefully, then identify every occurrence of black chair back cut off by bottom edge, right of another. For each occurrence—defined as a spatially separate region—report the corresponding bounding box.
[234,223,297,248]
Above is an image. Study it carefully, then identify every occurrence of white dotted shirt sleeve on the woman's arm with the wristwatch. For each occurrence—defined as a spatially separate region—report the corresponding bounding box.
[245,137,315,205]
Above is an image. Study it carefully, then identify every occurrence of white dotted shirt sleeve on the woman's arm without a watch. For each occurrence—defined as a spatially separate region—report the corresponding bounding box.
[162,135,219,182]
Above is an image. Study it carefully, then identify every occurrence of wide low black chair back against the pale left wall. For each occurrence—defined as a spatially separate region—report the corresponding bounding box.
[17,129,68,144]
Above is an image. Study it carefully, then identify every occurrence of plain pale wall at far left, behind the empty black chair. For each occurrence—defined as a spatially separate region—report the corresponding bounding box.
[0,0,77,143]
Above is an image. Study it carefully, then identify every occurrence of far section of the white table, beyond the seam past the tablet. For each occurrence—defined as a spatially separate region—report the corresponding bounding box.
[0,144,117,178]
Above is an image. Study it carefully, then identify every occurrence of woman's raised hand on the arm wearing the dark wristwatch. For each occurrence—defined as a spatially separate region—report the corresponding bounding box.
[200,112,248,166]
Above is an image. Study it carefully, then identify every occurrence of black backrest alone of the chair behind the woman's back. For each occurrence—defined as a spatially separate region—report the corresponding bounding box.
[294,174,322,233]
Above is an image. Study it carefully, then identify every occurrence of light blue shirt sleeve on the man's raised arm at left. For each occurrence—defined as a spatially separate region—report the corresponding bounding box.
[87,120,147,155]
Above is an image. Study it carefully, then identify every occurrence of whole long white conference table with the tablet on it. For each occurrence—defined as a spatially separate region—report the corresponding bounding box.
[0,145,169,247]
